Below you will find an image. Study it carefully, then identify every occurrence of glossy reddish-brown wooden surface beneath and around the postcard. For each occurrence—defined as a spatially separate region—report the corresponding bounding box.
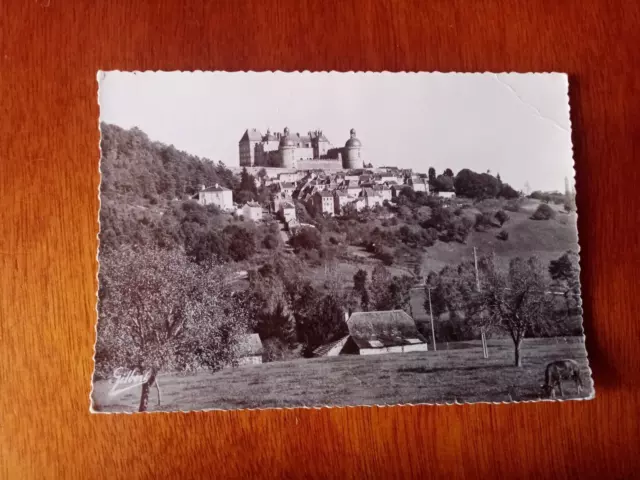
[0,0,640,479]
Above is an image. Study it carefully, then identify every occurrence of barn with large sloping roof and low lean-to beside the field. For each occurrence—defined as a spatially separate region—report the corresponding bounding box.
[314,310,428,357]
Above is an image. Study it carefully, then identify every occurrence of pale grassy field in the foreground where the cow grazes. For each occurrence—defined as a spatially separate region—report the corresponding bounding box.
[93,338,593,411]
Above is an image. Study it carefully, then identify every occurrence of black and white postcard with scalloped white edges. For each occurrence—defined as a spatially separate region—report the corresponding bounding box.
[91,71,595,413]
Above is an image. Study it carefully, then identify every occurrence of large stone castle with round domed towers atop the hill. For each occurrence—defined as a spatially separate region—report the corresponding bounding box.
[238,128,364,170]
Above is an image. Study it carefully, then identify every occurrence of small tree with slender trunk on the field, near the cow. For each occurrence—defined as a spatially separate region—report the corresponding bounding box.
[482,257,552,367]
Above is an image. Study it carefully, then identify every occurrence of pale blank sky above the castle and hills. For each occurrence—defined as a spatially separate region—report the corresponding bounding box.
[98,71,574,191]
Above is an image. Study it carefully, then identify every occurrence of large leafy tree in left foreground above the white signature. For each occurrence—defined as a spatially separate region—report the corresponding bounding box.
[95,247,247,411]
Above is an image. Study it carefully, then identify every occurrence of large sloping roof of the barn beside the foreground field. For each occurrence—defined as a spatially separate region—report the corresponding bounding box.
[347,310,426,348]
